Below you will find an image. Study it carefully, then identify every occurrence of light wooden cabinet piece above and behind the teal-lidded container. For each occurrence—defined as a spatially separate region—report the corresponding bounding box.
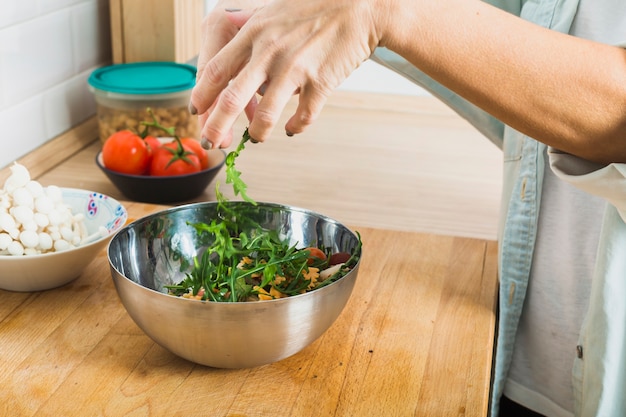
[109,0,204,64]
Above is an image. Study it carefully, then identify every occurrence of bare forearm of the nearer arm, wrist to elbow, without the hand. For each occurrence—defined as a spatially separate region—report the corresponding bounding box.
[378,0,626,163]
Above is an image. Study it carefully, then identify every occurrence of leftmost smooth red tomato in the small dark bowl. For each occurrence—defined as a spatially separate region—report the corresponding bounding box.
[102,130,152,175]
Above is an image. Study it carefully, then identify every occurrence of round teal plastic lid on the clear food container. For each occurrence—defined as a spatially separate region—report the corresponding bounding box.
[88,62,196,94]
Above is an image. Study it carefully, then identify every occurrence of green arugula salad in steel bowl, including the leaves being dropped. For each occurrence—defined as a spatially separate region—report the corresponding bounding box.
[167,129,361,302]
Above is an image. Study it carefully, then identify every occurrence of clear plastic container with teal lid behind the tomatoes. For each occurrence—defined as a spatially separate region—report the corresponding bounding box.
[88,62,198,142]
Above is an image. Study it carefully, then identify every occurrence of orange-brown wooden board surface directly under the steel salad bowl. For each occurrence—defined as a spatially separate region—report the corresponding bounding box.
[0,203,497,417]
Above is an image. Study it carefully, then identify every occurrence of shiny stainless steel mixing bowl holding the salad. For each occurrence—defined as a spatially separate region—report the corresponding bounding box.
[108,202,360,368]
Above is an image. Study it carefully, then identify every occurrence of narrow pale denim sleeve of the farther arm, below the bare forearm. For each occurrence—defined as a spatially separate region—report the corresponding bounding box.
[371,47,504,148]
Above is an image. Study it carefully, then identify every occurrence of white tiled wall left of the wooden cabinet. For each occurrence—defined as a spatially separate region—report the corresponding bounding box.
[0,0,111,167]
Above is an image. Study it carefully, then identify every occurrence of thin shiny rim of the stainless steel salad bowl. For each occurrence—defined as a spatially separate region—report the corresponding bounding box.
[106,200,363,308]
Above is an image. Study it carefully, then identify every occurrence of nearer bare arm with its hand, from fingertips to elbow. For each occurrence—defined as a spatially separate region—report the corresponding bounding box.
[192,0,626,163]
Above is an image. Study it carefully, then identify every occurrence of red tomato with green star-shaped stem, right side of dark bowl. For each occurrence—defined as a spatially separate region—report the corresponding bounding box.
[150,141,201,176]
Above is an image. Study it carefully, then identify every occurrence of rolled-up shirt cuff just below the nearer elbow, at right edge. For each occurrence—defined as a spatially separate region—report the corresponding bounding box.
[548,148,626,222]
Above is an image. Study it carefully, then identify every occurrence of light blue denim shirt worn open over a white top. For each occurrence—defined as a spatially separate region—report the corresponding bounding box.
[372,0,626,417]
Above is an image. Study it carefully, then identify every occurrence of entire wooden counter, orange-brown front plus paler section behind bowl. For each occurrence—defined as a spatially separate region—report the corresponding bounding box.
[0,93,501,417]
